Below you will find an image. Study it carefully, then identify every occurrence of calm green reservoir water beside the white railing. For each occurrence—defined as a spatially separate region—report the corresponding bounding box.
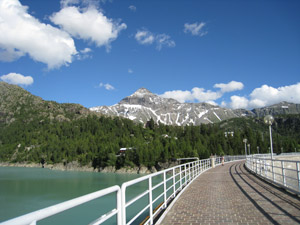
[0,167,144,225]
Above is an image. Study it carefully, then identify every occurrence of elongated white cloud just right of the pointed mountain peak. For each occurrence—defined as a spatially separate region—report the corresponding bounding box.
[161,81,244,105]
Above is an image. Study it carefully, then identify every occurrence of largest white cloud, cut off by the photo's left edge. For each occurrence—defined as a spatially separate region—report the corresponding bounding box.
[0,0,77,69]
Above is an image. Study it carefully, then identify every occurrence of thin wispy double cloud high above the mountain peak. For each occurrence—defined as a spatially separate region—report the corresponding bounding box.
[135,29,176,50]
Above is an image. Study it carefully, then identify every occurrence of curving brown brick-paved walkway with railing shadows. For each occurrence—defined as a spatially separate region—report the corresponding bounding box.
[161,162,300,225]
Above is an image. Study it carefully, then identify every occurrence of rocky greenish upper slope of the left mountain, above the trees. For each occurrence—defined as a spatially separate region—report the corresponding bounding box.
[0,82,91,125]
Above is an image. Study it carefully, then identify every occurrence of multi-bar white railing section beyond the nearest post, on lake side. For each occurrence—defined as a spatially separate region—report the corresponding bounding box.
[121,155,245,225]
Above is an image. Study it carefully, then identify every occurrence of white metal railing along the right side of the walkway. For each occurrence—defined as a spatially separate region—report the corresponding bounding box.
[246,153,300,194]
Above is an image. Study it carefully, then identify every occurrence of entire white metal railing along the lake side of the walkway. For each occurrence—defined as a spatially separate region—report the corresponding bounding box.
[0,155,245,225]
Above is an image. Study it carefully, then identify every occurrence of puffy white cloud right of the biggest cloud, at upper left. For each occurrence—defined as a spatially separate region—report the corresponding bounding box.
[50,5,127,50]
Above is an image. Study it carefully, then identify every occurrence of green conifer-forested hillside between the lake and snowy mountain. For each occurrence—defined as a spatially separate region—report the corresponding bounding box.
[0,82,300,169]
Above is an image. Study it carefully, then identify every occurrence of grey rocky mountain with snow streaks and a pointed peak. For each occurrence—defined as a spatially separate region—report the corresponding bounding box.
[90,88,300,126]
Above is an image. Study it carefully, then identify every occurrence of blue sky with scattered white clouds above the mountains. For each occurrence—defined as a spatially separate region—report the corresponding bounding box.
[0,0,300,109]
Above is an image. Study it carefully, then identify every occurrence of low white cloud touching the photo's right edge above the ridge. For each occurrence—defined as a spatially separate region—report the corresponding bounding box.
[229,83,300,109]
